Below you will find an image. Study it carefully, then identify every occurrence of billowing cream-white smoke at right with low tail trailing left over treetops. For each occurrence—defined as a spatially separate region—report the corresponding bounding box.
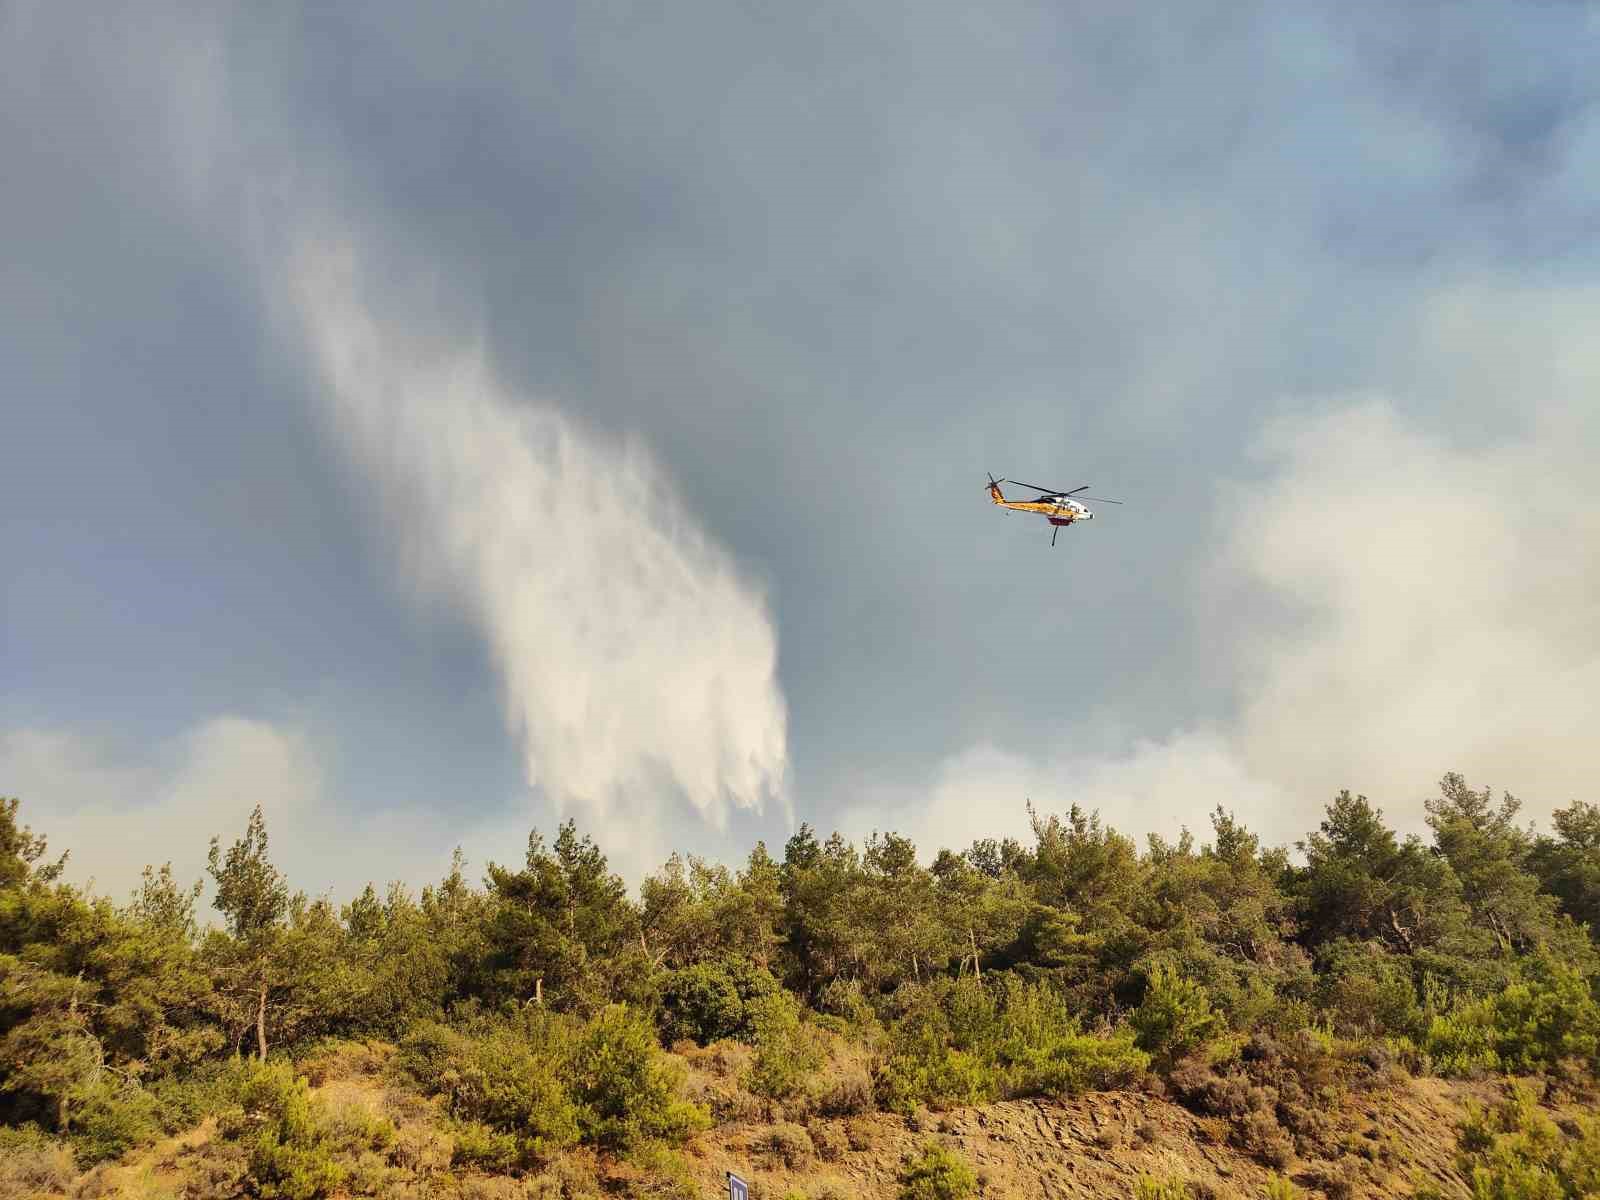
[876,286,1600,848]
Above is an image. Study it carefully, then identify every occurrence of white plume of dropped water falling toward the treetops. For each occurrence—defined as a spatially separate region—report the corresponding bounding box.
[293,242,787,858]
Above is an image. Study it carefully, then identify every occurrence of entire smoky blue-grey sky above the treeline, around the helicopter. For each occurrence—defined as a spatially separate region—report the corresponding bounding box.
[0,0,1600,894]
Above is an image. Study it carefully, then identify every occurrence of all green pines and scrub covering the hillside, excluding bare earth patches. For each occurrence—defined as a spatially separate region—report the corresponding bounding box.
[0,774,1600,1200]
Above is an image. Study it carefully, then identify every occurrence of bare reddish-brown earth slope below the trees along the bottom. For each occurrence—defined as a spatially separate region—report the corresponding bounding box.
[9,1046,1576,1200]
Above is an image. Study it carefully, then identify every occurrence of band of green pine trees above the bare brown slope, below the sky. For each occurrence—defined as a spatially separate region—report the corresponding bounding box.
[0,774,1600,1195]
